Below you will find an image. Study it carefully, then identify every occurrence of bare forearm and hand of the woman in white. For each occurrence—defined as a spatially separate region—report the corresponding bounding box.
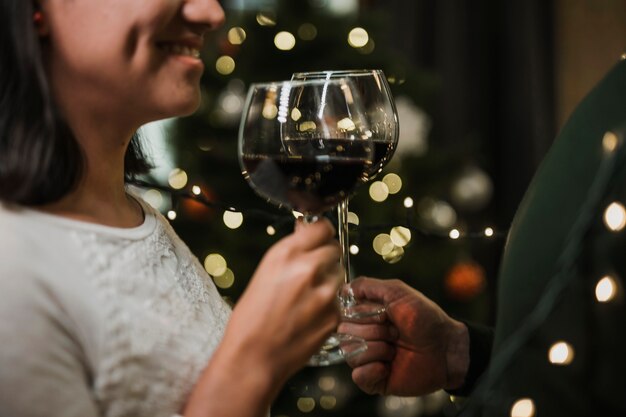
[185,220,342,417]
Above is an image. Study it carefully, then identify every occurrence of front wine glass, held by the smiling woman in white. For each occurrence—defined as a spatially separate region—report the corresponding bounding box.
[238,78,373,366]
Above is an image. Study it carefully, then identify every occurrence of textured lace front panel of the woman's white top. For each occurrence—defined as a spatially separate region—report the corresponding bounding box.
[73,213,230,417]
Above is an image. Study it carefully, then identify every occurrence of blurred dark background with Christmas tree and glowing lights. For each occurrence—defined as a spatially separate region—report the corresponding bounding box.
[136,0,626,417]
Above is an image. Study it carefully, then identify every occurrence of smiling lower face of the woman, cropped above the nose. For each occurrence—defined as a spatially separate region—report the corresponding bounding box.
[42,0,224,124]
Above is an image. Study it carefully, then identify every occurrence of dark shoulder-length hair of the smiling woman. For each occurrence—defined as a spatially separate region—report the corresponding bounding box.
[0,0,151,205]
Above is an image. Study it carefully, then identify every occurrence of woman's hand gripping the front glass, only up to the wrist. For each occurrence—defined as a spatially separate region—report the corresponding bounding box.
[225,220,342,379]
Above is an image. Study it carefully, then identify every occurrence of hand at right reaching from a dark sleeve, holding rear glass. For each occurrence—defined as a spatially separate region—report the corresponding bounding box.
[339,278,469,396]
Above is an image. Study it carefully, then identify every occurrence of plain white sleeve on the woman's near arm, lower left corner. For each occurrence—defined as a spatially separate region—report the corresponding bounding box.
[0,260,98,417]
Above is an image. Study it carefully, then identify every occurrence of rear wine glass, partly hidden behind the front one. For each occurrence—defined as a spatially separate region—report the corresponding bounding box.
[291,69,399,319]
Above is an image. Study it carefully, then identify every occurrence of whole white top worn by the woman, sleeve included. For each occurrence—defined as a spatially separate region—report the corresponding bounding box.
[0,198,230,417]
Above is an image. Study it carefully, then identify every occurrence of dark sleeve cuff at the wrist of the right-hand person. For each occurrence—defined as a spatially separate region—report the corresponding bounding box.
[447,321,494,397]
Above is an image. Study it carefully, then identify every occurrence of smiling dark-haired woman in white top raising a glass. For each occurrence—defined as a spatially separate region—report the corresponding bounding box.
[0,0,340,417]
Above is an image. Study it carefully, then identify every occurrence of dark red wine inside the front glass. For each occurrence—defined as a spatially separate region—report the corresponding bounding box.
[242,140,370,213]
